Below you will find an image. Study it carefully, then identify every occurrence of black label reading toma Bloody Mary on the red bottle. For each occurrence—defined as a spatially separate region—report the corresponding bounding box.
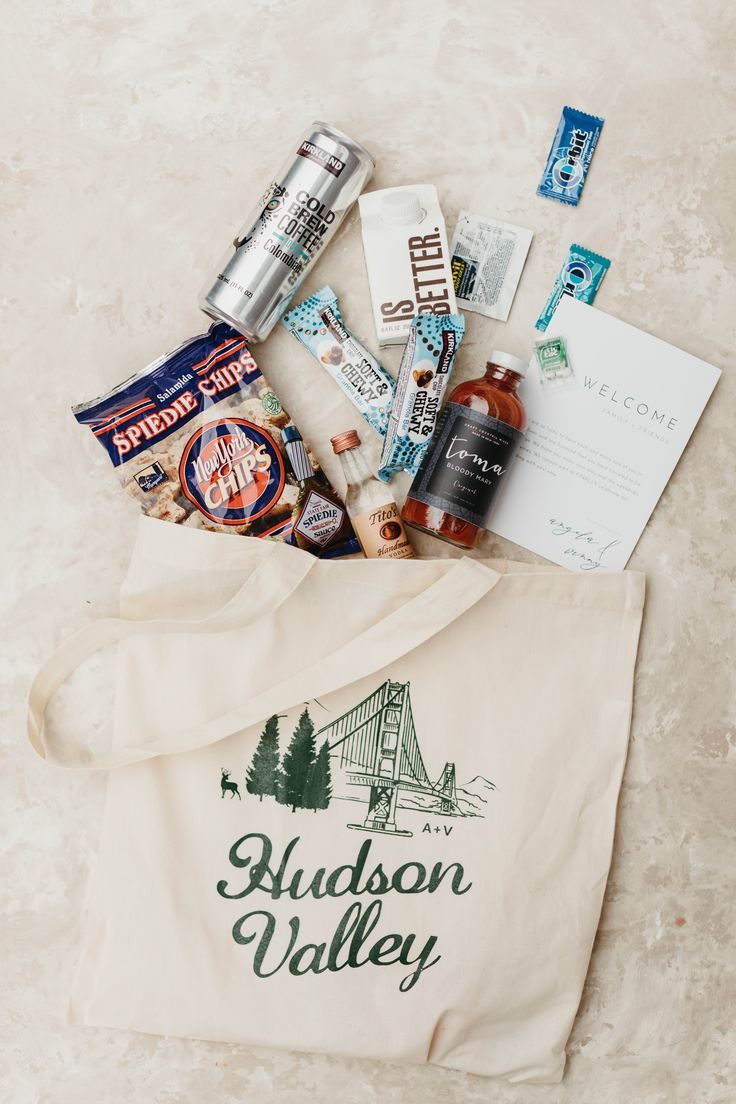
[409,403,522,529]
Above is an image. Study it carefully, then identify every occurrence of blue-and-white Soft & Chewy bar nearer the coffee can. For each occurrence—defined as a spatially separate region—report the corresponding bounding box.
[281,287,395,437]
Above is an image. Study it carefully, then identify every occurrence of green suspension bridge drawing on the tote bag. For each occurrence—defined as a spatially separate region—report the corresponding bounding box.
[317,679,472,836]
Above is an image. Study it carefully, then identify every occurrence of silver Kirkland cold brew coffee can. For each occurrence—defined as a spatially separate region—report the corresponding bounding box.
[200,123,375,341]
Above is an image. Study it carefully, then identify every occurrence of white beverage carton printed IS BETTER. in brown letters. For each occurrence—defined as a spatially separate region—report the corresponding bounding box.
[359,184,457,346]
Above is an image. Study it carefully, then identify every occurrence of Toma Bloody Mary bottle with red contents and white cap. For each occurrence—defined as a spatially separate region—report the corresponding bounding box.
[402,350,526,549]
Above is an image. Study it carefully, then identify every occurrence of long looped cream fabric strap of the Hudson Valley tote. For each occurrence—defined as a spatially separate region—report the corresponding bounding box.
[28,558,501,769]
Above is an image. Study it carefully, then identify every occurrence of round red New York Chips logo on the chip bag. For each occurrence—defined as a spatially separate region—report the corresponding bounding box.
[179,418,286,526]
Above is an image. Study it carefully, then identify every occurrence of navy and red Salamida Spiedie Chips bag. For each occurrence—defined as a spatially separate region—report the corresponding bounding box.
[74,322,360,555]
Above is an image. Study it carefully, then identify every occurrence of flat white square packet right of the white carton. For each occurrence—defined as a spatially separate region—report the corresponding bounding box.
[450,211,533,322]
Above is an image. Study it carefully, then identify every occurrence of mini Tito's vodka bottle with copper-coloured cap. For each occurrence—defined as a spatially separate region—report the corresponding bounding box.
[331,429,414,560]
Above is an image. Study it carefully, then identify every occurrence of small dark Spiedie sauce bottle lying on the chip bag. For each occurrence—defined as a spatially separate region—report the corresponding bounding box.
[281,425,358,555]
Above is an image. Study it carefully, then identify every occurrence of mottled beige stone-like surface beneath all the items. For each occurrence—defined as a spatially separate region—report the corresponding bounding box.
[0,0,736,1104]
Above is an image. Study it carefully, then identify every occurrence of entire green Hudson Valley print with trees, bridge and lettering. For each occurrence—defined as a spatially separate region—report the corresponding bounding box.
[216,679,495,992]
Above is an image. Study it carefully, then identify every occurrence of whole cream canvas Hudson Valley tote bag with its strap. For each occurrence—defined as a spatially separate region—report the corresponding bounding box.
[29,518,643,1082]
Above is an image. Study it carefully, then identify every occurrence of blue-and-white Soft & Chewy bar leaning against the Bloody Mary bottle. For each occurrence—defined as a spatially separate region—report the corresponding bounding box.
[378,315,465,482]
